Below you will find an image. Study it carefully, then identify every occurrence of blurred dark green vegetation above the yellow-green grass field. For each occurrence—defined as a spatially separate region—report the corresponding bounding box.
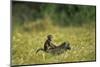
[12,1,96,26]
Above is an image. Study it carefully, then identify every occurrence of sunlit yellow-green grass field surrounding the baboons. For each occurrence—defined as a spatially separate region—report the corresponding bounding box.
[11,20,96,65]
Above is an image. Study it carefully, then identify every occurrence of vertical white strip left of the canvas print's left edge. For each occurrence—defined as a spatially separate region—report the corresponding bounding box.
[0,0,10,67]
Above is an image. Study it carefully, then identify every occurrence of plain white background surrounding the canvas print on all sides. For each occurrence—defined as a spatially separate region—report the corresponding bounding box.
[0,0,100,67]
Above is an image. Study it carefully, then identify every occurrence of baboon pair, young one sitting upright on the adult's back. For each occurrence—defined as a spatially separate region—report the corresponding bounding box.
[36,35,71,54]
